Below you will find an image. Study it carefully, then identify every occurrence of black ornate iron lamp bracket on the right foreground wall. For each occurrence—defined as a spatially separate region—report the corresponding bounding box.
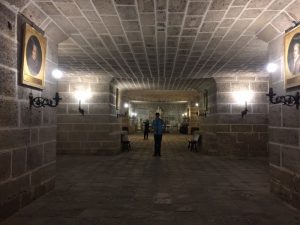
[266,88,300,109]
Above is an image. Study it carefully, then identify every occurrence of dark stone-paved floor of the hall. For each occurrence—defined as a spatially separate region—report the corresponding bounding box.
[1,135,300,225]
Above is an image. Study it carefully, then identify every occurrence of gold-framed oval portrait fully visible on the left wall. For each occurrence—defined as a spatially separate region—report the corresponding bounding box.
[21,23,47,89]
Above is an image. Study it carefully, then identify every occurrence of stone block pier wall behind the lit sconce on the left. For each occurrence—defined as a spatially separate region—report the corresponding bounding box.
[57,75,121,154]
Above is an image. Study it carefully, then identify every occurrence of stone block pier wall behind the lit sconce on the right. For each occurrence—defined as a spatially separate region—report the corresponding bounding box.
[201,74,269,157]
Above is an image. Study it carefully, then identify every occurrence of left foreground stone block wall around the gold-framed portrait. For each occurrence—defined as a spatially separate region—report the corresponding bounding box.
[0,1,57,221]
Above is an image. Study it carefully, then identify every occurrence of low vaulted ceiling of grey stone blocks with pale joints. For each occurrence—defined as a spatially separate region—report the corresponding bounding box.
[4,0,300,89]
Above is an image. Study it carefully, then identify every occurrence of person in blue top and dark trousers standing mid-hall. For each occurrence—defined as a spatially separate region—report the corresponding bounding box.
[152,113,165,156]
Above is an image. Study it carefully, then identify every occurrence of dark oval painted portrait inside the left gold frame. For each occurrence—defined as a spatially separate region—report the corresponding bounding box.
[26,36,42,76]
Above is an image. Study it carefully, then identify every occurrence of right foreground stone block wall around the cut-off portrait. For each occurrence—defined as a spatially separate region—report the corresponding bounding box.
[269,36,300,209]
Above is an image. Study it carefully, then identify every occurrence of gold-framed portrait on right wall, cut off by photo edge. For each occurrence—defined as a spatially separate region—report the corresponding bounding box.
[284,24,300,88]
